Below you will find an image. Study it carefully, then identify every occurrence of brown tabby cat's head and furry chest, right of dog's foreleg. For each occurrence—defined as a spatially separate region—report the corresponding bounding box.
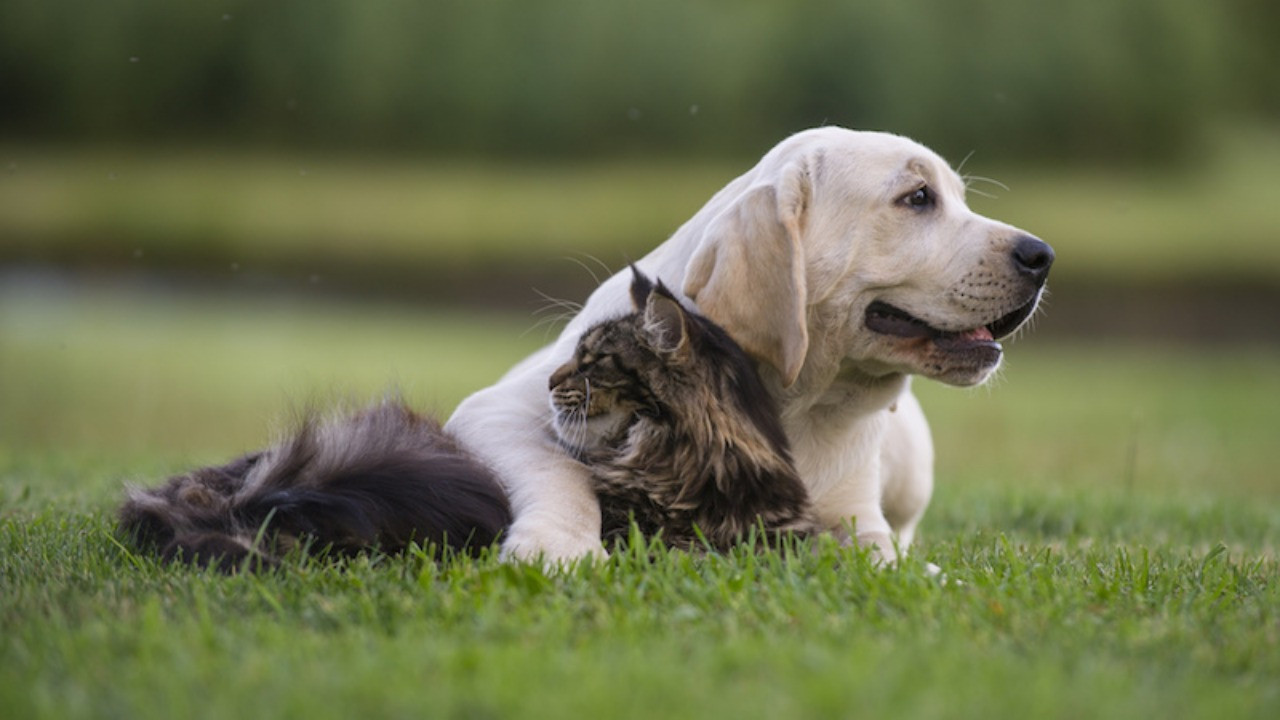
[550,272,814,550]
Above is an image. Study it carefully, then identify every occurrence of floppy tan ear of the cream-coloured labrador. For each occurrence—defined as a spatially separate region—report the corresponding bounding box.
[684,163,809,386]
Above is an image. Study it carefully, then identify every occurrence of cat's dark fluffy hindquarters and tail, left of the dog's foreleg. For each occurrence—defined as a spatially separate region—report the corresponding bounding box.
[119,401,511,570]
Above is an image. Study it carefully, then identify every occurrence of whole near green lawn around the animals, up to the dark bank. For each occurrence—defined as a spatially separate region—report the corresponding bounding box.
[0,283,1280,719]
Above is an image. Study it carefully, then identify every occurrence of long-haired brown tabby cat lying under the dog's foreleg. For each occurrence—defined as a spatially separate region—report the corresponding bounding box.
[120,266,813,569]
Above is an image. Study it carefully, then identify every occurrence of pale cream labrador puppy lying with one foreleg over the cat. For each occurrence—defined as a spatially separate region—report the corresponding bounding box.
[448,127,1053,561]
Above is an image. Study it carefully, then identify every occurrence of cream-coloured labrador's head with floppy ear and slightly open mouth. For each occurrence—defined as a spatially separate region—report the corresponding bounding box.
[684,128,1053,386]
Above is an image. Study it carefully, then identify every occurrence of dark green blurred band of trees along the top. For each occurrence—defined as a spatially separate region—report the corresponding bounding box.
[0,0,1280,159]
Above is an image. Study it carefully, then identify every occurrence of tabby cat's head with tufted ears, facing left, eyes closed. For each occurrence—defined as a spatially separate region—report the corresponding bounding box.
[550,268,772,454]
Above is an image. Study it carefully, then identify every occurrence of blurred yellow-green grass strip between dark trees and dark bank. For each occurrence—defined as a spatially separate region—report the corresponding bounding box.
[0,121,1280,284]
